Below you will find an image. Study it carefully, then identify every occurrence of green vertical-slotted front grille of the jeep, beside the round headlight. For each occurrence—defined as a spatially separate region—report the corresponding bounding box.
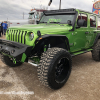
[8,30,27,44]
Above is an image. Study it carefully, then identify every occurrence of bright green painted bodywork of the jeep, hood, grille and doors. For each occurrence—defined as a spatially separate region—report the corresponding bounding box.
[6,10,100,62]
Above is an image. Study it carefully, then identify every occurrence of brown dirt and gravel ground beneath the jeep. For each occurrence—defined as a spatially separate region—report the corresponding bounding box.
[0,37,100,100]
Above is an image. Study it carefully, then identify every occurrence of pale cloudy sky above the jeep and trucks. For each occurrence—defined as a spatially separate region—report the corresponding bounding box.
[0,0,94,20]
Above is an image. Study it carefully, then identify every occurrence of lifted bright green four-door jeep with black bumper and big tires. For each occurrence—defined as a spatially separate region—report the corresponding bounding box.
[0,9,100,89]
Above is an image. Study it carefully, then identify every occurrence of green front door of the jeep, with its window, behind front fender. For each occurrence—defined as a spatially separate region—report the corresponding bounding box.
[71,13,88,52]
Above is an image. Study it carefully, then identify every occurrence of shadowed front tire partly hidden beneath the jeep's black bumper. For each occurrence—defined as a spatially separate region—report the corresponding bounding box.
[1,55,22,67]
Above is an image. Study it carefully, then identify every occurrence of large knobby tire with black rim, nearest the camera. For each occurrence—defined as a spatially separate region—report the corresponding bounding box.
[38,48,72,89]
